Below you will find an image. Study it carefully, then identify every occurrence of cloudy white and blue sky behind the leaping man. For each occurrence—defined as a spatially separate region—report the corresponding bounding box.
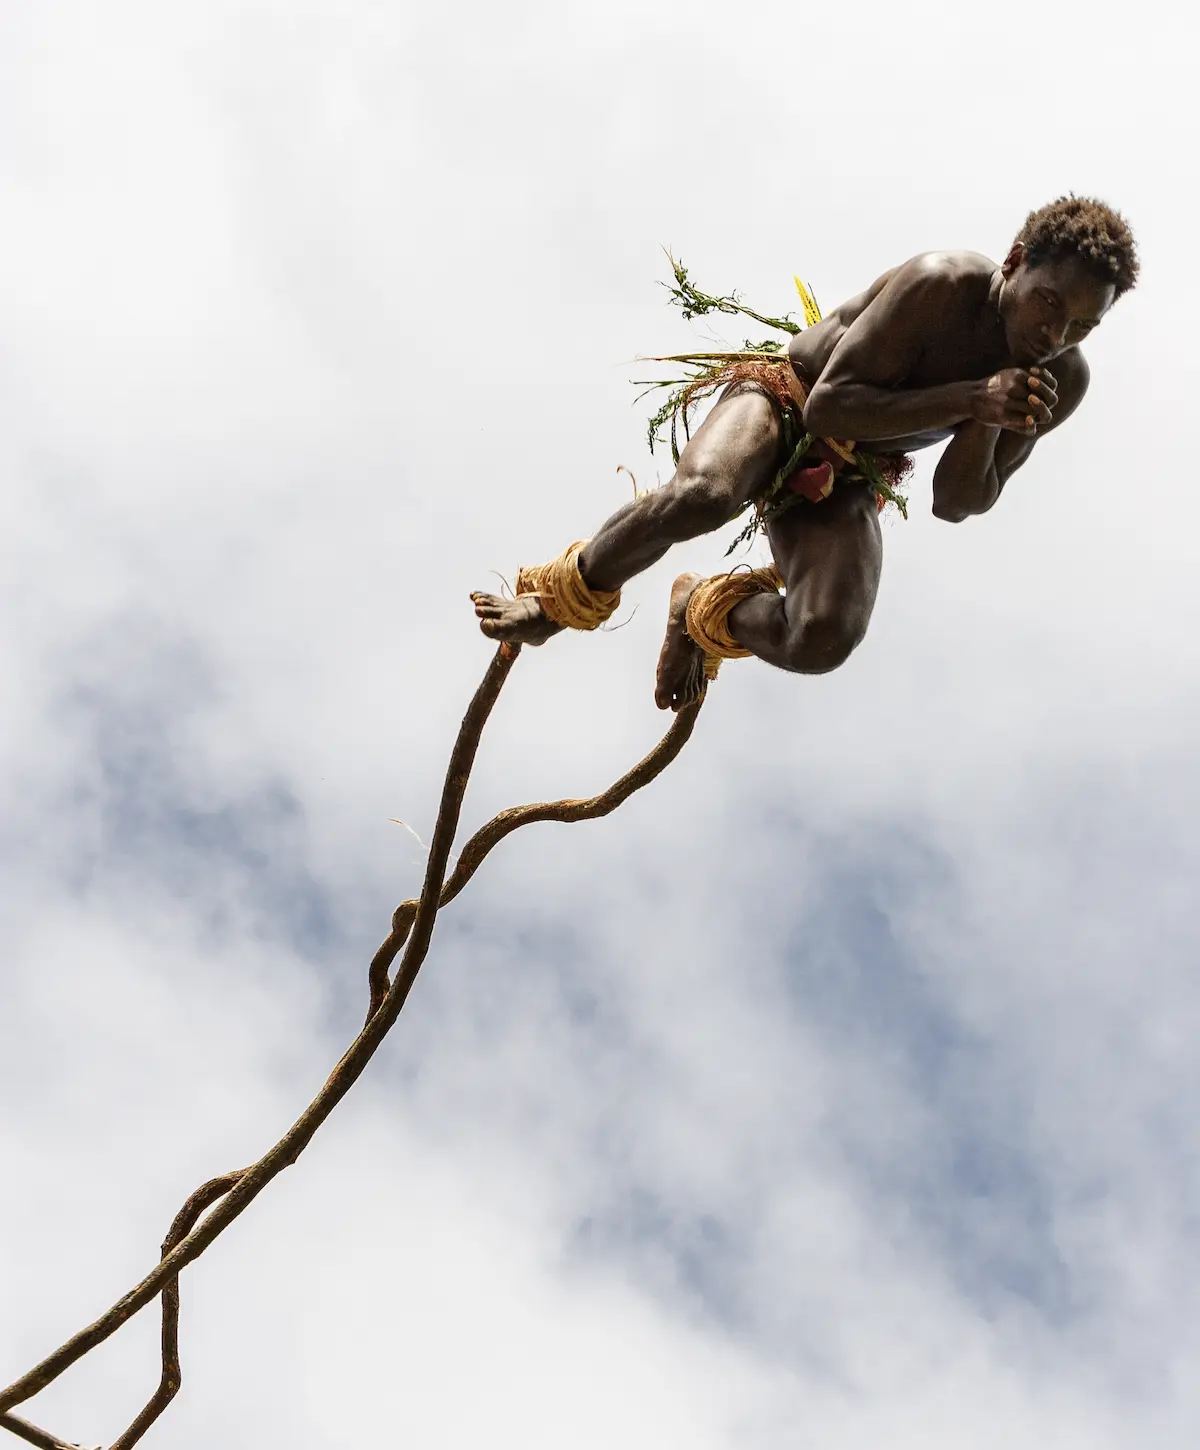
[0,0,1200,1450]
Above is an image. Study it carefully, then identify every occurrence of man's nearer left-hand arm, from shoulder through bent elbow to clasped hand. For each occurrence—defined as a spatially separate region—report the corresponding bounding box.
[804,255,1049,442]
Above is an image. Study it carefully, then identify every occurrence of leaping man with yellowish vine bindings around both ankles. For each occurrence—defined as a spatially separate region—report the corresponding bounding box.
[471,197,1138,711]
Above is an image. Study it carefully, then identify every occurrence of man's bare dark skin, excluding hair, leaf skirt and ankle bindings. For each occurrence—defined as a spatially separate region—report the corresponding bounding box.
[471,242,1116,711]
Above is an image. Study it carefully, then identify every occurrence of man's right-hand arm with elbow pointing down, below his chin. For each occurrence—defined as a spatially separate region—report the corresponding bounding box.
[933,348,1091,523]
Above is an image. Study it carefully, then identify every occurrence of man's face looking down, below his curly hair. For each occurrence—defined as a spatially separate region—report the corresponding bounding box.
[1000,242,1116,367]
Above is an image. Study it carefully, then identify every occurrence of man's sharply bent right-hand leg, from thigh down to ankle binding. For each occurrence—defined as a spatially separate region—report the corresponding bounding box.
[729,481,883,674]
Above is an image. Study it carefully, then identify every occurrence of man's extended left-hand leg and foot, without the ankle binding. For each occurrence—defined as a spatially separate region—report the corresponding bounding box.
[471,390,781,652]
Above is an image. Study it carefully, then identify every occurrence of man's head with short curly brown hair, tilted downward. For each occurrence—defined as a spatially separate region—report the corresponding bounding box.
[1000,196,1138,364]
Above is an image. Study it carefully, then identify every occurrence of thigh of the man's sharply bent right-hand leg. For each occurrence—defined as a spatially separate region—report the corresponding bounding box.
[767,481,883,639]
